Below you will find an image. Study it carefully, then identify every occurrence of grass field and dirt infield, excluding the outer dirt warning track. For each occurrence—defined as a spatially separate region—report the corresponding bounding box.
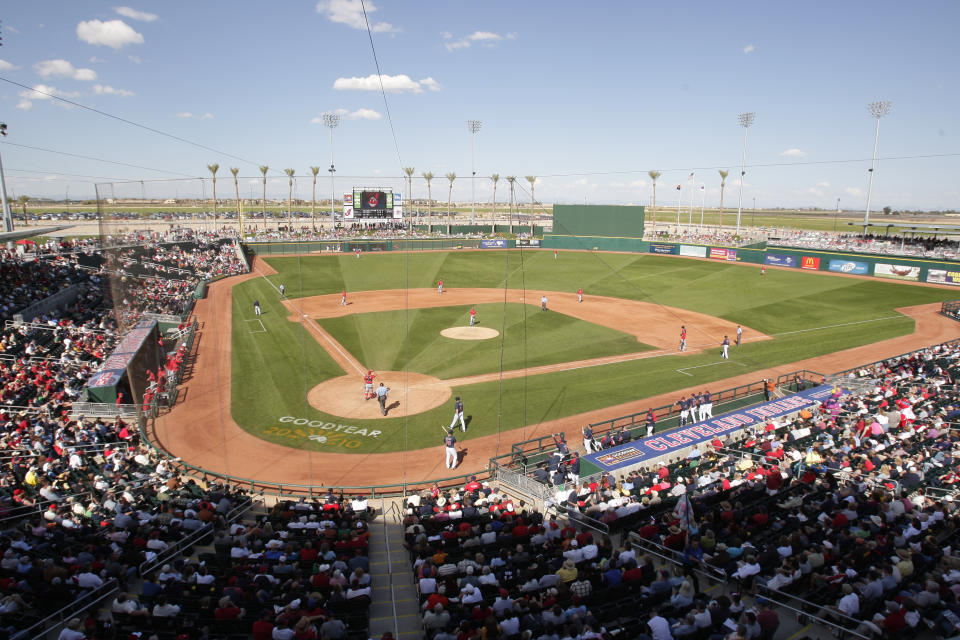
[206,250,955,454]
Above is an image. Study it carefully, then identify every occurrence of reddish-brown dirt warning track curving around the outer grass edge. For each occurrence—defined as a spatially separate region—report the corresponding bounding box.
[152,260,960,486]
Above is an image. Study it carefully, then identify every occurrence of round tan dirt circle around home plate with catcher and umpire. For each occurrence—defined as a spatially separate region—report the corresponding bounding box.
[307,371,451,420]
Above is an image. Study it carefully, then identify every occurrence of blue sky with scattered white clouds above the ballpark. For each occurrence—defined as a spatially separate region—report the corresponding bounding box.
[0,0,960,210]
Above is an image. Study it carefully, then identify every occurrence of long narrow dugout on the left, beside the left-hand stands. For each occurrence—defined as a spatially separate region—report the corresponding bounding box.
[84,320,164,404]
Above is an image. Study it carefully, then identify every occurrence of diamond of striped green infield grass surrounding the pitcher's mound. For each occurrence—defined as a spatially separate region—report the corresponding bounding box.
[318,300,653,379]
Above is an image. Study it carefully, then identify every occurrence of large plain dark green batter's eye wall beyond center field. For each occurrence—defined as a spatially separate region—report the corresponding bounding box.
[541,204,648,251]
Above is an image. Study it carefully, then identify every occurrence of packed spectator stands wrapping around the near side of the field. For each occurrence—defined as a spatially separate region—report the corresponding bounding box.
[0,232,960,640]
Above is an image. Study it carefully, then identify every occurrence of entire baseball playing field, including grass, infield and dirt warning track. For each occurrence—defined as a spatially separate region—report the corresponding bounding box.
[154,250,956,485]
